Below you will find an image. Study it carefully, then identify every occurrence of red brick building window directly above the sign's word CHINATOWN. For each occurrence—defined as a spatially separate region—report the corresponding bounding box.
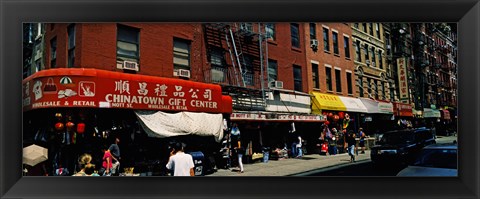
[117,25,140,65]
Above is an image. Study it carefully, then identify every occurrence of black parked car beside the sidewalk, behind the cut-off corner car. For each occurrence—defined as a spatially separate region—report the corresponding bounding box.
[370,128,436,165]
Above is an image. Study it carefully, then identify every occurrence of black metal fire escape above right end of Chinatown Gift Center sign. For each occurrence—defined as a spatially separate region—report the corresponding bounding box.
[203,23,268,111]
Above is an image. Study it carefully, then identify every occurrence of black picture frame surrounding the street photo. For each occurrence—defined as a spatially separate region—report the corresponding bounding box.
[0,0,480,198]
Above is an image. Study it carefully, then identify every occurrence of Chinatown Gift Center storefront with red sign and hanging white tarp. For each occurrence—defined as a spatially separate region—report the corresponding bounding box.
[22,68,232,176]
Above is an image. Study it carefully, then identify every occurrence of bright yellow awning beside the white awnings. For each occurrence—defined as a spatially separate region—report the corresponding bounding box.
[312,92,347,114]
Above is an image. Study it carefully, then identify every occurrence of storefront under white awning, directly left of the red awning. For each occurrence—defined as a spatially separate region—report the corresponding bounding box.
[360,98,395,135]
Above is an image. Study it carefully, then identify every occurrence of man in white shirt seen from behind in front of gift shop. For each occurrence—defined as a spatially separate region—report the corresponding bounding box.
[167,143,195,176]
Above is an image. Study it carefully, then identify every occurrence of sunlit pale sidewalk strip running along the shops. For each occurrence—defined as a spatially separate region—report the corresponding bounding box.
[207,150,370,176]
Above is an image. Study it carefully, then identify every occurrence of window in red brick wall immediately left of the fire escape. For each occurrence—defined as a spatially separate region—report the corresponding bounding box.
[173,38,190,70]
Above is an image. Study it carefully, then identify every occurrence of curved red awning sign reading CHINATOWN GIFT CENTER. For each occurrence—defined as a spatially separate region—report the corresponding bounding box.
[22,68,232,113]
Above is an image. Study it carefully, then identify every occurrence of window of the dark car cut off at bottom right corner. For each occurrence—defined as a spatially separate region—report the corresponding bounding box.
[413,149,457,169]
